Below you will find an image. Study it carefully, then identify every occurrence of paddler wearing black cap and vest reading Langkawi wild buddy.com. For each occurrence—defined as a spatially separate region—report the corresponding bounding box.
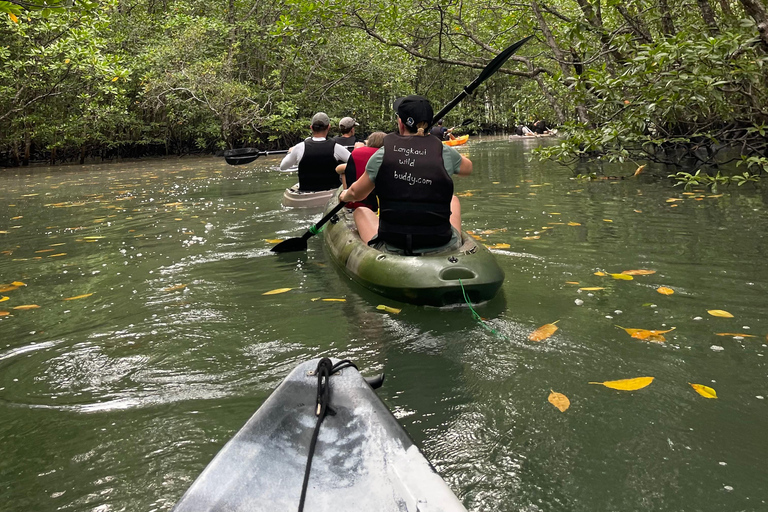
[340,95,472,254]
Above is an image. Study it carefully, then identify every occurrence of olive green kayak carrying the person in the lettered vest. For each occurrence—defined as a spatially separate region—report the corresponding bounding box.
[323,194,504,307]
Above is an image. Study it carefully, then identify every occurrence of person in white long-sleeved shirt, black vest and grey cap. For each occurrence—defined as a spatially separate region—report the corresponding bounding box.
[280,112,349,192]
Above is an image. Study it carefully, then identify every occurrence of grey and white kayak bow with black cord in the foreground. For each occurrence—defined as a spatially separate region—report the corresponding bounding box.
[173,359,466,512]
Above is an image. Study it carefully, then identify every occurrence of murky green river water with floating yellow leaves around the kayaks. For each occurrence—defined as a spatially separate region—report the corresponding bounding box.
[0,139,768,512]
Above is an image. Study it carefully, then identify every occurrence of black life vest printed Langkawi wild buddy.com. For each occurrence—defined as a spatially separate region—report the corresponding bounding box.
[376,134,453,252]
